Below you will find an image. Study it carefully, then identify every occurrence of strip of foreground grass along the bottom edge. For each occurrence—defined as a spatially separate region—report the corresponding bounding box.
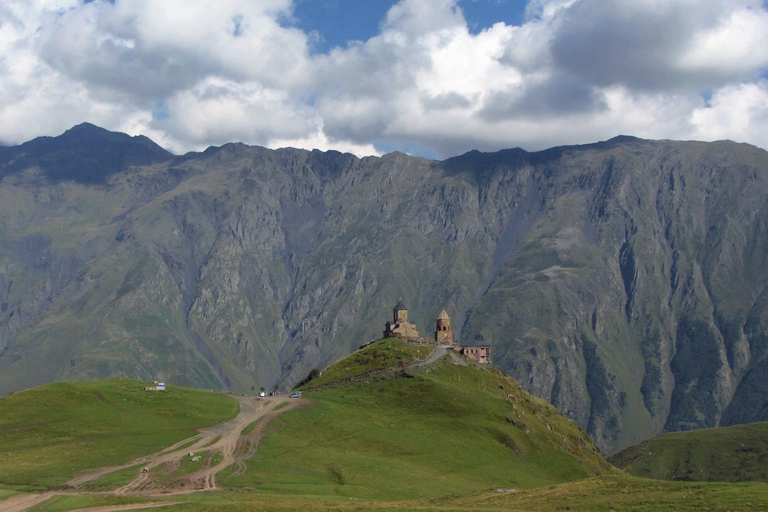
[27,475,768,512]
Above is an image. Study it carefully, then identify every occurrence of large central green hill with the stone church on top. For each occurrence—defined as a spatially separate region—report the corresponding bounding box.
[223,340,611,500]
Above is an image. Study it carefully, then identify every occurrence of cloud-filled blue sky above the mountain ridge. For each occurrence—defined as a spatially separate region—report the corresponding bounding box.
[0,0,768,159]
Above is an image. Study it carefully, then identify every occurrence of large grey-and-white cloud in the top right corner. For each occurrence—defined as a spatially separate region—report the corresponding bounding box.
[552,0,768,91]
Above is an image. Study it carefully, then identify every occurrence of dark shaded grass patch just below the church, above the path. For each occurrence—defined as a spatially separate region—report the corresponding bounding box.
[302,338,434,389]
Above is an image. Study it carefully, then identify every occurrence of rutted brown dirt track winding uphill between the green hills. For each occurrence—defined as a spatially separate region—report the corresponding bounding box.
[0,397,306,512]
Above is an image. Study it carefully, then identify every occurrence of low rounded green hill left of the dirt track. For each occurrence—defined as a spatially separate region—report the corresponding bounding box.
[0,378,238,490]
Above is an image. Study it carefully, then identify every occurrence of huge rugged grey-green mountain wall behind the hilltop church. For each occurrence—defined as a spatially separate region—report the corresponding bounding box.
[0,126,768,452]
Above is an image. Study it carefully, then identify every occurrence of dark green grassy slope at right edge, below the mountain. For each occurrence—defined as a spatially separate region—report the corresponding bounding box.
[610,422,768,482]
